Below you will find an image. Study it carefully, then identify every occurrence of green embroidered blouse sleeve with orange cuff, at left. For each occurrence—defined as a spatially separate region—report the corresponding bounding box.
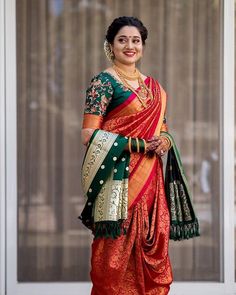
[83,75,113,129]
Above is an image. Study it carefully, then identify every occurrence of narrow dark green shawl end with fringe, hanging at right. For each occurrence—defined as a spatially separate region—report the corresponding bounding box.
[161,132,200,241]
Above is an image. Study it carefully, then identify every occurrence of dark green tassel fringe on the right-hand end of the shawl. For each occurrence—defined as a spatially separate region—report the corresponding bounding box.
[170,219,200,241]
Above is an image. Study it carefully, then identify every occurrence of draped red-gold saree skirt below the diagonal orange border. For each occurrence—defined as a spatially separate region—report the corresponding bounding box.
[91,160,172,295]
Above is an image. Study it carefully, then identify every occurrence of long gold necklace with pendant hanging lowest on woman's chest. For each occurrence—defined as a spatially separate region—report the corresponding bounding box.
[113,65,153,108]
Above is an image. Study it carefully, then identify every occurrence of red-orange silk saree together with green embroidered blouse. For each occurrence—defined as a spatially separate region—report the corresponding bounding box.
[83,72,172,295]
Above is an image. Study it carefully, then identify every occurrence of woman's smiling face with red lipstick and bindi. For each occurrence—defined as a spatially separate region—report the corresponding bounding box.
[111,26,143,65]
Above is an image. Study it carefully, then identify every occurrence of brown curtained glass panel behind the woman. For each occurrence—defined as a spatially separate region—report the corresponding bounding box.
[16,0,223,282]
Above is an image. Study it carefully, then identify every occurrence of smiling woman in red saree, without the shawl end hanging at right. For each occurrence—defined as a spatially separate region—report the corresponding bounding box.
[80,17,199,295]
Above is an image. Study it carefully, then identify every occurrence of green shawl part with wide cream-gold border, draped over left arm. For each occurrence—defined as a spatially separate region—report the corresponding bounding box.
[79,130,130,238]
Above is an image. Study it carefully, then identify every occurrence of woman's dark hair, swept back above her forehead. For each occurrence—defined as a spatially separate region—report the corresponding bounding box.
[106,16,148,45]
